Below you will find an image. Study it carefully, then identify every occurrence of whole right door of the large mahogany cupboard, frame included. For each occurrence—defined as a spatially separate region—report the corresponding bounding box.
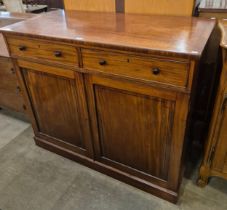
[86,76,188,187]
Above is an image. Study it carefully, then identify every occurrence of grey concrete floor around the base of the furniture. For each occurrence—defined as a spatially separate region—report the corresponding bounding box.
[0,110,227,210]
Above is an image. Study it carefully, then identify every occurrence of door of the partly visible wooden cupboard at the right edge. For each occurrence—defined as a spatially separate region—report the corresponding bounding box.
[212,99,227,174]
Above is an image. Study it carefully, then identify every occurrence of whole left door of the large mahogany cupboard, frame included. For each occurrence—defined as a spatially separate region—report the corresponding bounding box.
[21,67,90,158]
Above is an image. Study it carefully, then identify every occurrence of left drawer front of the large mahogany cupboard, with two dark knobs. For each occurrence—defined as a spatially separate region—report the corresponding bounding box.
[7,37,78,66]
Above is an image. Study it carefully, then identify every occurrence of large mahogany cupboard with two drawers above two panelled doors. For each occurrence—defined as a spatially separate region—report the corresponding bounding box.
[2,11,215,202]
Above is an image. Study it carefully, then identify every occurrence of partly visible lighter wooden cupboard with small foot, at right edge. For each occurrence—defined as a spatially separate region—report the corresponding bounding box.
[198,20,227,186]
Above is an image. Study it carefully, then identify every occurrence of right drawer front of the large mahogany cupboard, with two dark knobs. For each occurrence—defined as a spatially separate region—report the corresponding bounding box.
[82,49,189,87]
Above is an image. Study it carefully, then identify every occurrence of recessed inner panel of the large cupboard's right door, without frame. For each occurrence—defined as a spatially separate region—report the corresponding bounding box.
[94,85,174,180]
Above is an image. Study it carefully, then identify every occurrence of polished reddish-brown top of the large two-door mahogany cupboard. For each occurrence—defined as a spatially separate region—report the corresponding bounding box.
[0,10,215,57]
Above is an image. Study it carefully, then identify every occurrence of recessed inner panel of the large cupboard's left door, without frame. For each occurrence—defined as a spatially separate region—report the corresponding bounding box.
[23,71,84,148]
